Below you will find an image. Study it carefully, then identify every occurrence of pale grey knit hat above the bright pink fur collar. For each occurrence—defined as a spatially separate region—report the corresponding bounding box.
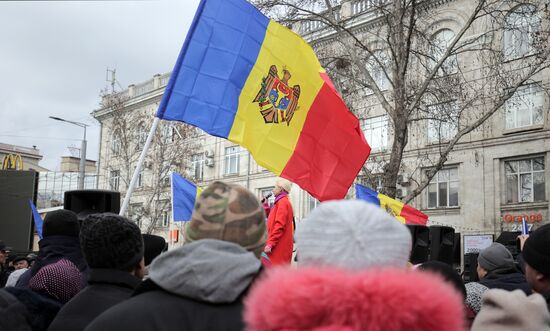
[295,200,411,270]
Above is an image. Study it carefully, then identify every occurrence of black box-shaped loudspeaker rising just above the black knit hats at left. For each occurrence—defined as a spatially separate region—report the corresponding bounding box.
[63,190,120,220]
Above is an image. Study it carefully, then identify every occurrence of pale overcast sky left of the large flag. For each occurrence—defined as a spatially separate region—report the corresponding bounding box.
[0,0,202,170]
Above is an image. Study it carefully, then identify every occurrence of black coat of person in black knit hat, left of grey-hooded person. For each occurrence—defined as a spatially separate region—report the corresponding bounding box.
[48,269,141,331]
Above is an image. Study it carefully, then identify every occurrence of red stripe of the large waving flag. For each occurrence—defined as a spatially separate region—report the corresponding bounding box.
[281,74,370,201]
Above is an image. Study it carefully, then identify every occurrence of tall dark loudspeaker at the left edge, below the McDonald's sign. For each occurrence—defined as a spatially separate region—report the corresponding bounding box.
[0,170,38,252]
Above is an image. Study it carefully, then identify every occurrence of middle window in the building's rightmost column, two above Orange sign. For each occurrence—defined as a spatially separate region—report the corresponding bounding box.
[505,84,544,129]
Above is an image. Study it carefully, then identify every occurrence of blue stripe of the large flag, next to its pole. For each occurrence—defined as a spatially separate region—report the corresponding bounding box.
[156,0,269,138]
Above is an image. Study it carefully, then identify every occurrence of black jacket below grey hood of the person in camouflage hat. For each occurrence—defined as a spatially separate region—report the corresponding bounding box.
[86,280,248,331]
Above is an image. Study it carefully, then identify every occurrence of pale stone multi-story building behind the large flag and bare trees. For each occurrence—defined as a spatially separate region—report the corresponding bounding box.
[93,0,550,245]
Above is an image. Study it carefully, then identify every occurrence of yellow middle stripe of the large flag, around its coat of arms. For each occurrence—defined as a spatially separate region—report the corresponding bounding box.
[228,21,324,175]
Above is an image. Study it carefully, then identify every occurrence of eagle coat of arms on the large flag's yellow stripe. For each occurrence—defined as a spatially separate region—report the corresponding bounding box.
[253,65,300,126]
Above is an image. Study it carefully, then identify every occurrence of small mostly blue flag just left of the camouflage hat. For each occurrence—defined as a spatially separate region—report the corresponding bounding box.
[171,172,202,222]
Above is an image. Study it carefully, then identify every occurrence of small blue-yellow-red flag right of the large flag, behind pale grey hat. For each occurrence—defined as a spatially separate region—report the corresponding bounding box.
[355,184,428,225]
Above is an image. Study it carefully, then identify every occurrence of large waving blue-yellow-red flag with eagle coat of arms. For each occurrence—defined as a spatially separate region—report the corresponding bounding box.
[156,0,370,200]
